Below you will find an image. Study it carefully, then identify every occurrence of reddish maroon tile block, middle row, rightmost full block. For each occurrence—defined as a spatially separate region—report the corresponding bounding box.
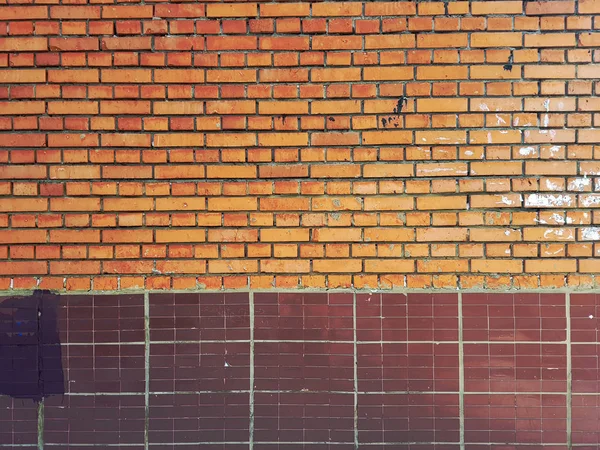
[464,343,567,392]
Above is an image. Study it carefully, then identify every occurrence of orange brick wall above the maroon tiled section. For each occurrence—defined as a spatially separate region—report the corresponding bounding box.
[0,0,600,291]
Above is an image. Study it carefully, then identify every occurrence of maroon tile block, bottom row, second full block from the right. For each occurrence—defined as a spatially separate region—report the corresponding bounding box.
[358,394,460,442]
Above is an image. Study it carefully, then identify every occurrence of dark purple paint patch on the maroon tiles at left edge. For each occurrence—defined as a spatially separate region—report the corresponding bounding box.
[0,291,65,402]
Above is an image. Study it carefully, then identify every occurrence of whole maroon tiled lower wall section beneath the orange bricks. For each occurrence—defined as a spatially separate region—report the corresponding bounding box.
[0,292,600,450]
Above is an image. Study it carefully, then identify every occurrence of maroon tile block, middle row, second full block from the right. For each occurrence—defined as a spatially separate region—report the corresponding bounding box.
[357,342,459,392]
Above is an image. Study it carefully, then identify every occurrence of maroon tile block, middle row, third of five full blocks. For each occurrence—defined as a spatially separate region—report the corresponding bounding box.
[254,342,354,391]
